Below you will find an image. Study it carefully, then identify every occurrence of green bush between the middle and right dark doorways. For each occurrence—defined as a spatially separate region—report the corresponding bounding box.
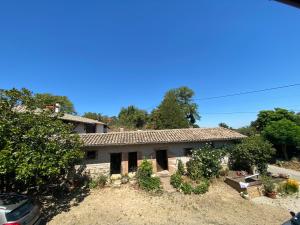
[137,159,161,192]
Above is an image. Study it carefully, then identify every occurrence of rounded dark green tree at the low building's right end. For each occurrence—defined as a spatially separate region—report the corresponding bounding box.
[230,135,275,173]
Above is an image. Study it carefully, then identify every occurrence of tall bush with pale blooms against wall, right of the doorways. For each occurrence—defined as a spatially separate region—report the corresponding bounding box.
[187,144,225,180]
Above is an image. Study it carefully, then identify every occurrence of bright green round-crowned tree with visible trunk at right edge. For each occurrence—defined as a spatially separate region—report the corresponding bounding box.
[262,119,300,160]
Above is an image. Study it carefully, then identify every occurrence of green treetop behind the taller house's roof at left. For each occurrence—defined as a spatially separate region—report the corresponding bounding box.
[35,93,76,114]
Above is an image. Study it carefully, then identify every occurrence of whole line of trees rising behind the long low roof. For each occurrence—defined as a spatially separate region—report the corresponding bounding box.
[83,87,200,130]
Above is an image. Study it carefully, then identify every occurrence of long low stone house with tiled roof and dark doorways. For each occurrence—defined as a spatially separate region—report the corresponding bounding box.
[80,128,245,175]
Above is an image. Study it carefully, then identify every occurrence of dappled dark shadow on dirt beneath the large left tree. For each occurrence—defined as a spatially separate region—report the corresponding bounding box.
[39,186,90,224]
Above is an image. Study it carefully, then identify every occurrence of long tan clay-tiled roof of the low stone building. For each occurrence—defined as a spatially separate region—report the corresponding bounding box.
[80,128,246,146]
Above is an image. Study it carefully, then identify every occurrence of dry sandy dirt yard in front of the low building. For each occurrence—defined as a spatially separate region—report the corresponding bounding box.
[48,181,289,225]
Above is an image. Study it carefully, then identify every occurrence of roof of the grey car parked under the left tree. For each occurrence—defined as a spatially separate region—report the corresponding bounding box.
[0,193,28,211]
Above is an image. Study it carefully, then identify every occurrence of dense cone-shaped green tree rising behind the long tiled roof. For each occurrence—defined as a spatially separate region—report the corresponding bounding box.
[151,92,189,129]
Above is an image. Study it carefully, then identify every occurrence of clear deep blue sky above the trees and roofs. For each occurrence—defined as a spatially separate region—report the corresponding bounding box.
[0,0,300,127]
